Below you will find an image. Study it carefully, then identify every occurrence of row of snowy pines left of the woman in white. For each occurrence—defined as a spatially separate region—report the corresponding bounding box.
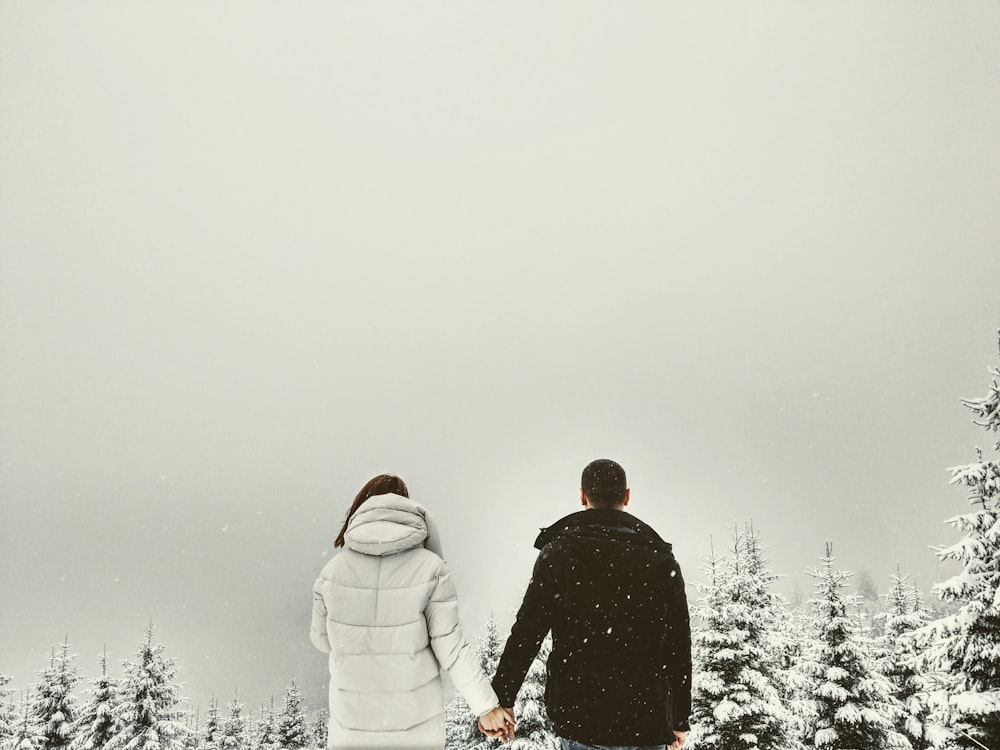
[0,624,327,750]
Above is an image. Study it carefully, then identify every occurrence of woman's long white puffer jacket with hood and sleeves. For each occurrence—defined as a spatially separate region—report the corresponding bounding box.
[310,495,499,750]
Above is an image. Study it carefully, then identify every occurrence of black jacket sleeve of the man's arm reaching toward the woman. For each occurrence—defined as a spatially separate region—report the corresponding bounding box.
[493,544,559,708]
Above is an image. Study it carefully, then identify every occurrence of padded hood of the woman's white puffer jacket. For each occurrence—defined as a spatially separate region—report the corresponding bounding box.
[344,494,442,557]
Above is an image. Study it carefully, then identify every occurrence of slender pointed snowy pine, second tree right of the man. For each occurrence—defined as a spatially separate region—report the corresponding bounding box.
[802,542,910,750]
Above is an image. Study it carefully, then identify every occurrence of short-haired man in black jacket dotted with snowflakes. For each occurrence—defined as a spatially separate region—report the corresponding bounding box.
[486,459,691,750]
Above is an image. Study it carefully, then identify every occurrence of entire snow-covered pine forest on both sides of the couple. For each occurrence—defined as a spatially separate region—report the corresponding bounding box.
[0,340,1000,750]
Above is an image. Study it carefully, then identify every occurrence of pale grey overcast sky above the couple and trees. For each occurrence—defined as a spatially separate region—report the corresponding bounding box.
[0,0,1000,706]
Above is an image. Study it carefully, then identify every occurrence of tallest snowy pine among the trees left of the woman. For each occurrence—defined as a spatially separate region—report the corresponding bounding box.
[106,623,187,750]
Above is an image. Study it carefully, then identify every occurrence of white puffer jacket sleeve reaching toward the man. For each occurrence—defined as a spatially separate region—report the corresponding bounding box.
[424,560,500,716]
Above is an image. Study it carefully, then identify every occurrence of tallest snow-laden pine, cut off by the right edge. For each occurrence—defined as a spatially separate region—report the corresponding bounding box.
[919,334,1000,750]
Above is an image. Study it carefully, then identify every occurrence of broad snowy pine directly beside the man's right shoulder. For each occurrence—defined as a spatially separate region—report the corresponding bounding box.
[689,525,798,750]
